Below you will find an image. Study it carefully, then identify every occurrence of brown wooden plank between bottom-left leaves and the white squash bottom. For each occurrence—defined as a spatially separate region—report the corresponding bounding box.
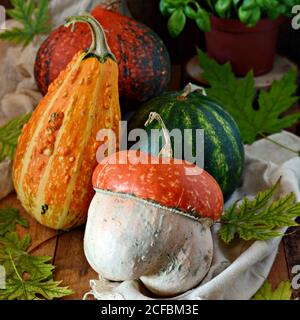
[54,226,98,300]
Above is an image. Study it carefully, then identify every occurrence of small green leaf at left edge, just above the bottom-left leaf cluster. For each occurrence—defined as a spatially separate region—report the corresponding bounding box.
[0,208,28,236]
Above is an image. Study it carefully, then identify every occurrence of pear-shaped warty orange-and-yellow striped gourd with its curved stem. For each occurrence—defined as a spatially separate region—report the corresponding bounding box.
[13,15,121,229]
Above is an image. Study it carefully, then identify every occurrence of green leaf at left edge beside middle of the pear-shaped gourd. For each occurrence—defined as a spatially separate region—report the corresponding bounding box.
[0,113,31,161]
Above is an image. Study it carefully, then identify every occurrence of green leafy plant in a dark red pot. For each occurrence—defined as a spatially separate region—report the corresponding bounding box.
[160,0,298,76]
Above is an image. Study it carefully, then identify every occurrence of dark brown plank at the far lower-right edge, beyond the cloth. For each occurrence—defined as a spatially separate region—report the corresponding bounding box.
[283,218,300,298]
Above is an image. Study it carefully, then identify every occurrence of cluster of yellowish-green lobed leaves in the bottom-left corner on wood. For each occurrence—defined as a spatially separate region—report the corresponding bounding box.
[0,208,72,300]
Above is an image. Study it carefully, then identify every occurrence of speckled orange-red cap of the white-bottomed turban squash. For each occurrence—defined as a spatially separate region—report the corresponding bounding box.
[92,150,223,221]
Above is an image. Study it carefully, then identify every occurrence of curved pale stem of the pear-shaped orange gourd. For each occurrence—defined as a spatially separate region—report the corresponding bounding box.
[65,13,116,63]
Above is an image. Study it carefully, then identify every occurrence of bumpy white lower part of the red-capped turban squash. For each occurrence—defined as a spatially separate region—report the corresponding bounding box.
[84,191,213,296]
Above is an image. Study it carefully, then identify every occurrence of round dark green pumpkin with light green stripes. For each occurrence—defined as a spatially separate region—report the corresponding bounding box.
[128,91,244,198]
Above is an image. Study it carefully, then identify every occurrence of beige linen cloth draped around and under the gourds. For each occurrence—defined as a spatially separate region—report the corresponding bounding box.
[0,0,300,299]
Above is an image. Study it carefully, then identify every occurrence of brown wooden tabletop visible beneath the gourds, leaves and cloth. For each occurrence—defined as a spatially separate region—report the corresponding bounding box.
[0,193,300,299]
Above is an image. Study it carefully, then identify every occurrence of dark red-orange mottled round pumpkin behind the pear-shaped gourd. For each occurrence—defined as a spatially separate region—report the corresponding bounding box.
[34,6,170,107]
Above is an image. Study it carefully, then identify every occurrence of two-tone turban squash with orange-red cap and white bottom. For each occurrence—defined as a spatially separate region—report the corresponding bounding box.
[84,114,223,296]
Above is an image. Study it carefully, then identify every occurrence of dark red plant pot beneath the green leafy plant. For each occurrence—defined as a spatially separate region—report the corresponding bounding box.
[205,17,284,76]
